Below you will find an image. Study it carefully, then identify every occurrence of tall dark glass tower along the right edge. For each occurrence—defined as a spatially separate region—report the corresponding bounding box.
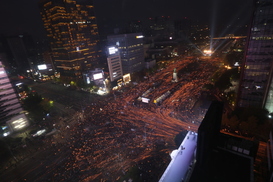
[237,0,273,112]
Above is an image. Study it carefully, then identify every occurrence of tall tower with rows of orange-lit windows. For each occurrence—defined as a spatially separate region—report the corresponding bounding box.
[40,0,99,80]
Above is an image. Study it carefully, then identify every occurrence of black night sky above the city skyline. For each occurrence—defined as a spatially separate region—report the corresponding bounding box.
[0,0,252,38]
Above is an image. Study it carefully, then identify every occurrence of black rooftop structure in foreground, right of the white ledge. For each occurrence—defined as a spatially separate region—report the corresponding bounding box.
[189,101,258,182]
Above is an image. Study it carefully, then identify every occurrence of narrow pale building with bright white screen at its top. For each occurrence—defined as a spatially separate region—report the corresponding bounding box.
[107,46,123,82]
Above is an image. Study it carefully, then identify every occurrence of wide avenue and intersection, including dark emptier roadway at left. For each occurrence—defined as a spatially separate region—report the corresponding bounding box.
[1,56,217,181]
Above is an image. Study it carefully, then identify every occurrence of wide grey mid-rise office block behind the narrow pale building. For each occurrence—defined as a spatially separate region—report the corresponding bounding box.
[107,33,144,74]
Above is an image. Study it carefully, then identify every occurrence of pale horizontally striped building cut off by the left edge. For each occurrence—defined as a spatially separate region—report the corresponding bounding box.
[0,61,29,137]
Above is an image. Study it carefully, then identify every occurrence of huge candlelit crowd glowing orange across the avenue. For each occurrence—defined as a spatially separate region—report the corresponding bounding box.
[2,56,219,181]
